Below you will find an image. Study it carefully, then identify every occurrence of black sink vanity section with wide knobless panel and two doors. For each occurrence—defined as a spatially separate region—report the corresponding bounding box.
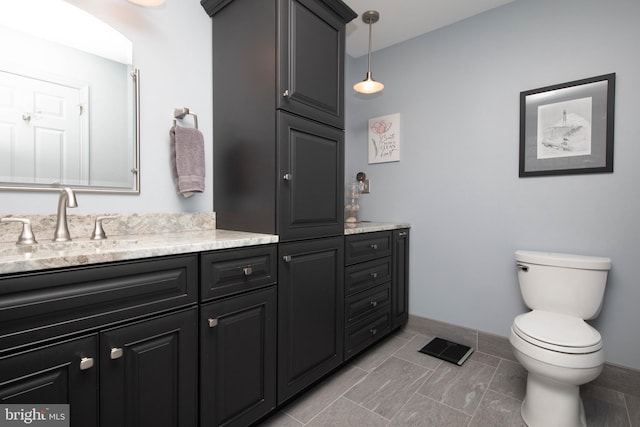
[0,255,198,427]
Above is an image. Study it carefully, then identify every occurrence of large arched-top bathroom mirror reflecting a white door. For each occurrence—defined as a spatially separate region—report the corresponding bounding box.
[0,0,140,194]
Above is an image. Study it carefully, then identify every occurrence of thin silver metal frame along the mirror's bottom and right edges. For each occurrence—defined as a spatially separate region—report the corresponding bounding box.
[0,68,140,194]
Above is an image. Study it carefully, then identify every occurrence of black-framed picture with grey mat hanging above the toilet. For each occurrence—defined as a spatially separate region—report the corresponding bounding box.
[519,73,616,178]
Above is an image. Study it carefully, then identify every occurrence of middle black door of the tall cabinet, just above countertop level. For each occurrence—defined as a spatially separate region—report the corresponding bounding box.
[278,113,344,241]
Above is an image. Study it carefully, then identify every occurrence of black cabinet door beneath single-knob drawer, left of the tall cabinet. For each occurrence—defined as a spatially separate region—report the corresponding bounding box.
[200,286,277,427]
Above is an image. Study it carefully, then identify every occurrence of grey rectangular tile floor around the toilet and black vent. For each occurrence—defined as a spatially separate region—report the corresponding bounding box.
[260,328,640,427]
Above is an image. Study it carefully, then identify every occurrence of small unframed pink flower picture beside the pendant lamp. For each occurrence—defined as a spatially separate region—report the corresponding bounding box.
[368,113,400,164]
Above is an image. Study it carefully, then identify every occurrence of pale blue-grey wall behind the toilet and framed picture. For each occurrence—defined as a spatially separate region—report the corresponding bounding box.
[345,0,640,369]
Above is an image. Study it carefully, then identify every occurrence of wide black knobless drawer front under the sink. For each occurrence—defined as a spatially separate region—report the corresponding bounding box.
[0,255,198,352]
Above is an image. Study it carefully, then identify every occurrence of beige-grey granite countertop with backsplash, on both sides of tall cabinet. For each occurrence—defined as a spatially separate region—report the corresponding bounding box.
[0,213,410,275]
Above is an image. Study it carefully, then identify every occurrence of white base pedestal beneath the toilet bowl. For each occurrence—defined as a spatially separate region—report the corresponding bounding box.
[521,373,587,427]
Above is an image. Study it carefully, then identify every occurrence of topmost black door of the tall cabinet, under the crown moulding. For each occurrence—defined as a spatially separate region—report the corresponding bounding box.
[277,0,345,129]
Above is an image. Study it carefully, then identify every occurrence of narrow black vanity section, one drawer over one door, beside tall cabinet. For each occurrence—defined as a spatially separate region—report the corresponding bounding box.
[200,245,277,427]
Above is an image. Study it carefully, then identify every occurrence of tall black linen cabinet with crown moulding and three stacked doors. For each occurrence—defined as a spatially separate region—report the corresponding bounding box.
[201,0,357,418]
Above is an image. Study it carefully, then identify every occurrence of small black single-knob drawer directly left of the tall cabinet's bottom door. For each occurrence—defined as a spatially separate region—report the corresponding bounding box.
[200,245,277,301]
